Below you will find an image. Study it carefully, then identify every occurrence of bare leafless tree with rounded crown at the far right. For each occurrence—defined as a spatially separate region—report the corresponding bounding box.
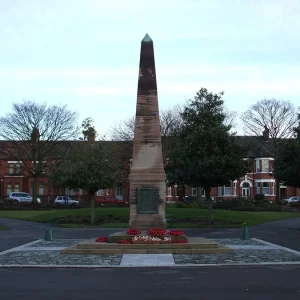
[241,98,299,201]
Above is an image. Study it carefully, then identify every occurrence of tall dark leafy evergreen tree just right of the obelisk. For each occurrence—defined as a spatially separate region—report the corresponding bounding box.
[166,88,248,225]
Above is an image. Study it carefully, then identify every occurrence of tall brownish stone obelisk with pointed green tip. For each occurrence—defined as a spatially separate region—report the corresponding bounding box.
[129,34,166,229]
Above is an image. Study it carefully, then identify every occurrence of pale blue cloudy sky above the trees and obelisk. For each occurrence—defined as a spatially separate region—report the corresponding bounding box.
[0,0,300,134]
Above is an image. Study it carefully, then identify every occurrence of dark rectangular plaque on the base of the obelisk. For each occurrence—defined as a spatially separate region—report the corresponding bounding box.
[136,188,159,214]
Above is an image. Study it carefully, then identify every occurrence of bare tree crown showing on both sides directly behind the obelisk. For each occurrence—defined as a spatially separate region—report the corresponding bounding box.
[110,105,182,141]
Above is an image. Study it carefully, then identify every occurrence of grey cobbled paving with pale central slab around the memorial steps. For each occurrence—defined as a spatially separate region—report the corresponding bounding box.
[0,239,300,267]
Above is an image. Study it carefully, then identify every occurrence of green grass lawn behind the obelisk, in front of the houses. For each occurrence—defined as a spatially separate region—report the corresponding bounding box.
[0,207,300,228]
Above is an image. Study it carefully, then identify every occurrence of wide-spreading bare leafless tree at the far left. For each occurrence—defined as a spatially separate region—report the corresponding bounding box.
[0,101,77,202]
